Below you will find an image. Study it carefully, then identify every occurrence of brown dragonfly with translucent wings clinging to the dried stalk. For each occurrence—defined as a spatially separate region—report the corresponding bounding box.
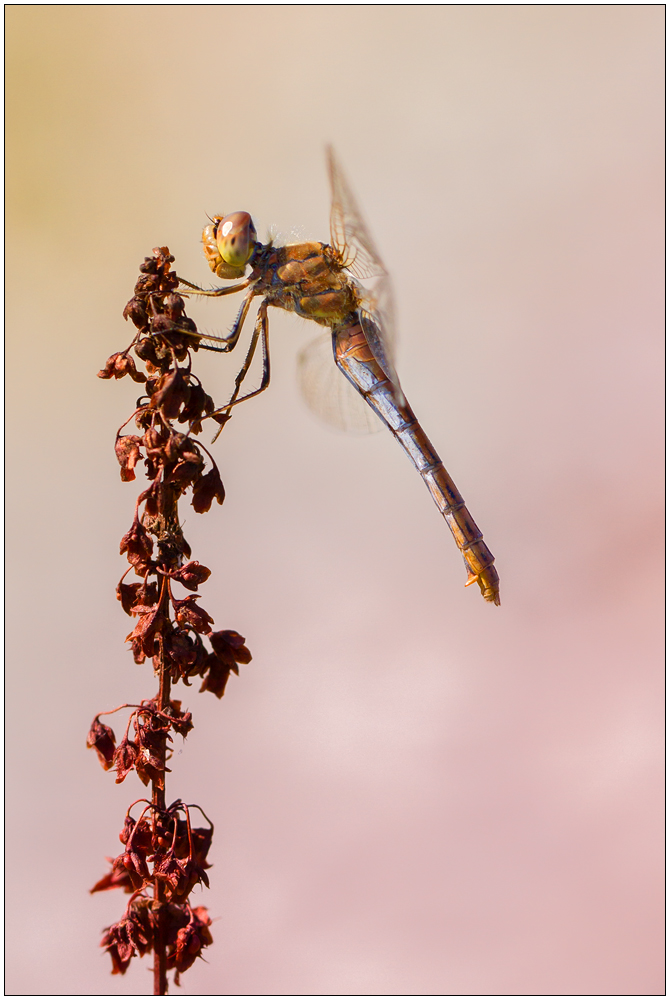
[179,147,500,604]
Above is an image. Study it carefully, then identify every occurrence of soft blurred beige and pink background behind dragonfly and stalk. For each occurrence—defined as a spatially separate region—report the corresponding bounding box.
[7,4,663,995]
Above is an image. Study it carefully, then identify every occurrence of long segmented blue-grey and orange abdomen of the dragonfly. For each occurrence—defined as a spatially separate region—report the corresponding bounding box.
[333,322,500,604]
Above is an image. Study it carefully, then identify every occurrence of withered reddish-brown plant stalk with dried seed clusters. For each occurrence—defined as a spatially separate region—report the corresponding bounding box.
[87,247,251,996]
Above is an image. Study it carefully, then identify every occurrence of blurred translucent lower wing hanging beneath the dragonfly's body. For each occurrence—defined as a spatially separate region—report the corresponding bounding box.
[298,333,383,434]
